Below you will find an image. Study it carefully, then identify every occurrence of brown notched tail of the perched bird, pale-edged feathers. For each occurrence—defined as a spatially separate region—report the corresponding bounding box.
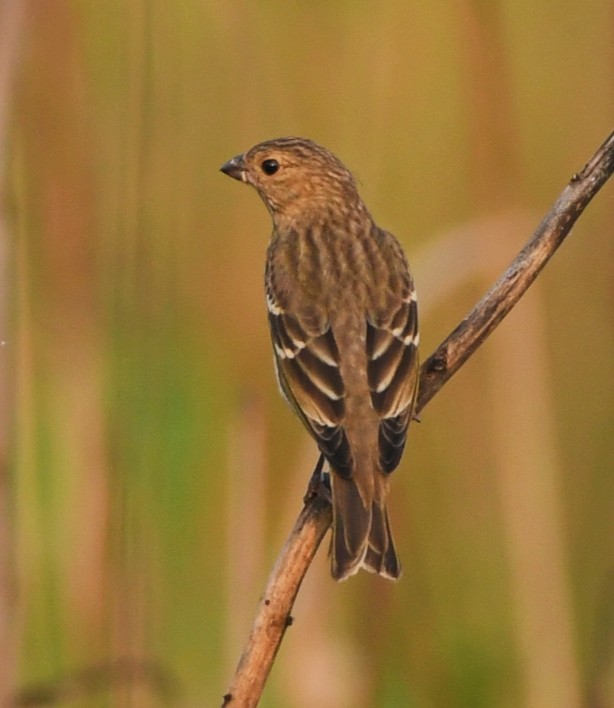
[331,472,401,580]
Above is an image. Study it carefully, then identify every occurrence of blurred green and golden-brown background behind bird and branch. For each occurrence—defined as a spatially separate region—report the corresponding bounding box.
[0,0,614,708]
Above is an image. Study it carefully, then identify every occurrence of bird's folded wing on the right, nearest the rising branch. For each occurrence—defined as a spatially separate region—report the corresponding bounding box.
[367,272,419,472]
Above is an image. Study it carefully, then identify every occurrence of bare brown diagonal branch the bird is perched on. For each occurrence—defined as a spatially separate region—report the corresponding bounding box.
[223,133,614,708]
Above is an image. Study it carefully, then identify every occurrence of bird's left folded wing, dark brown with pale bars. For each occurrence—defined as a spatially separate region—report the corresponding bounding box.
[267,288,352,476]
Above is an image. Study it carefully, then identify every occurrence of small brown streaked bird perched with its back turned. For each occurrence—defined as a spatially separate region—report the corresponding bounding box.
[221,137,418,580]
